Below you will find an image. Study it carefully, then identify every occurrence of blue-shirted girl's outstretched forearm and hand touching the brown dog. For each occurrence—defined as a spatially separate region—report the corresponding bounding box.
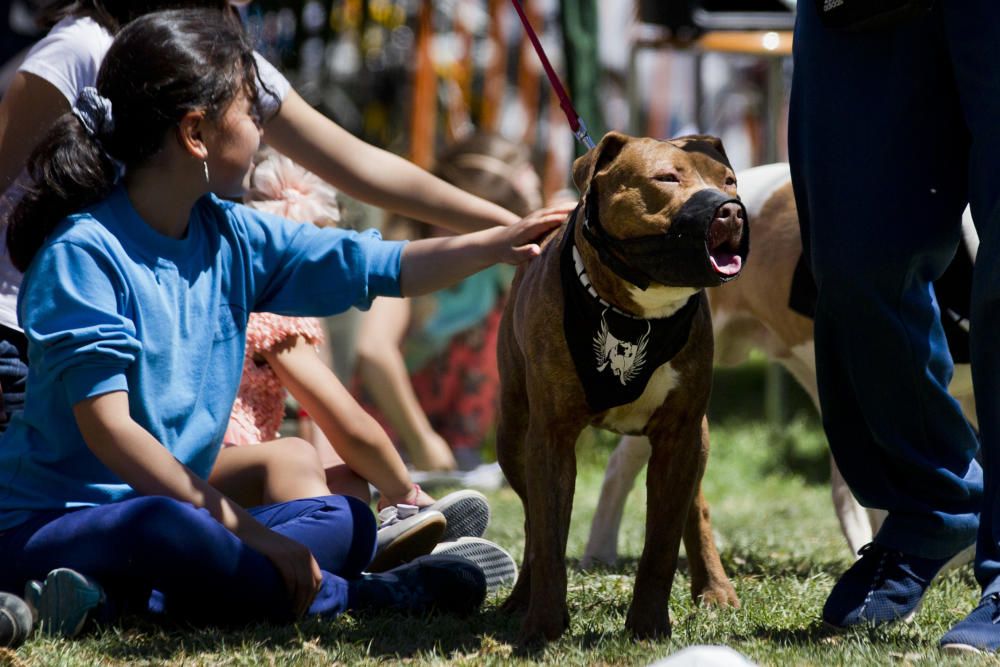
[399,203,573,296]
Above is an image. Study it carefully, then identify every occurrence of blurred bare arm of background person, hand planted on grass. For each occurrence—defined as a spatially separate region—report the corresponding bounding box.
[357,299,457,470]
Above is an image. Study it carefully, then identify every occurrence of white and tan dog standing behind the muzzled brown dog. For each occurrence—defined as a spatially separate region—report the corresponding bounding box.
[581,164,978,568]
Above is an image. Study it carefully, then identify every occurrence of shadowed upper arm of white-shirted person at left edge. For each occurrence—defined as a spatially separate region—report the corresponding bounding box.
[0,72,70,194]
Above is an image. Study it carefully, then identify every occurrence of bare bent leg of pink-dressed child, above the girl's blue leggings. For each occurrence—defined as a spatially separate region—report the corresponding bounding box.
[208,438,330,507]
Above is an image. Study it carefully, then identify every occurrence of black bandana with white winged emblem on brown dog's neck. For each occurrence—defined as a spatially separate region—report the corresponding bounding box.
[559,212,704,412]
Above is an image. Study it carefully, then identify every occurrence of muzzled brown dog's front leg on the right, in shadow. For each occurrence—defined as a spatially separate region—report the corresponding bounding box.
[625,417,707,637]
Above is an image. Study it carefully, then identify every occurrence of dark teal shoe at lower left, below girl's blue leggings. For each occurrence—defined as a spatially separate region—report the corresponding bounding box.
[24,567,105,637]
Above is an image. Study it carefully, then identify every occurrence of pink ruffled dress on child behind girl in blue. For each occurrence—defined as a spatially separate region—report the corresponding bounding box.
[223,313,323,447]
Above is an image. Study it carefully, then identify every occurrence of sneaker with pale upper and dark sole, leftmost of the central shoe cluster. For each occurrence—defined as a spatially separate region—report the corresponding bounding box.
[368,505,448,572]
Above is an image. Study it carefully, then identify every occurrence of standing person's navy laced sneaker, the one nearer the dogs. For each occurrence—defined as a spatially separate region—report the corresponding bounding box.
[823,542,951,628]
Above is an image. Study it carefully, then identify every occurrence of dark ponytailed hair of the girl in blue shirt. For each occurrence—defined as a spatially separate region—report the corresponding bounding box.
[7,9,258,272]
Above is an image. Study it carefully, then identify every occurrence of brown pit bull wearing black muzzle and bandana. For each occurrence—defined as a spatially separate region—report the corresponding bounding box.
[497,128,749,644]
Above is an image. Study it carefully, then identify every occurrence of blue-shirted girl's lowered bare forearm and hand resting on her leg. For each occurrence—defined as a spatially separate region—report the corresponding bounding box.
[73,391,322,616]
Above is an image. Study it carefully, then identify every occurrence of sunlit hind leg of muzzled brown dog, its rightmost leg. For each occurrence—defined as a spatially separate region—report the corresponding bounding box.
[684,417,740,607]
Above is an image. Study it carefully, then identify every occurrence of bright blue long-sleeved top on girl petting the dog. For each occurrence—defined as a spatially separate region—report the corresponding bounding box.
[0,187,404,530]
